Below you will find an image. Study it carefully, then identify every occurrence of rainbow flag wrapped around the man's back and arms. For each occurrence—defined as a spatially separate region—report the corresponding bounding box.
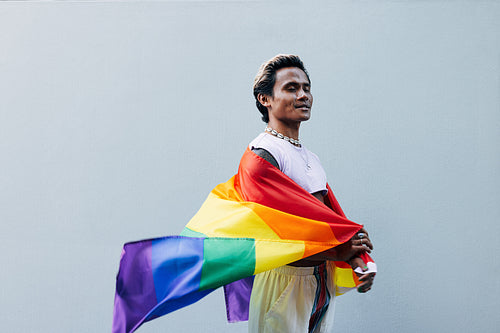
[113,149,374,333]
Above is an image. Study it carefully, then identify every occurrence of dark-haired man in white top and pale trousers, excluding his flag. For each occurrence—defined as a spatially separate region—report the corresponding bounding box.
[249,55,374,333]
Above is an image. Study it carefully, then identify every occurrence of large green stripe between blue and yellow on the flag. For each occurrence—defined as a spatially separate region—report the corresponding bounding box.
[200,238,255,290]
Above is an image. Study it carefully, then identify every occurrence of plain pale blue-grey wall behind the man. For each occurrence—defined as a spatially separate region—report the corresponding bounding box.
[0,1,500,332]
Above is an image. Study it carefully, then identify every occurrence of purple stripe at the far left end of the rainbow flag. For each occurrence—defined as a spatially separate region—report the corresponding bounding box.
[113,240,157,333]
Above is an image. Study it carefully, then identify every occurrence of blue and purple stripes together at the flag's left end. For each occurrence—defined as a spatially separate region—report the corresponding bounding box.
[113,236,218,333]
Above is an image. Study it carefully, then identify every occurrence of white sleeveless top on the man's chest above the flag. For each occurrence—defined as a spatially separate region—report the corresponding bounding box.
[249,132,327,195]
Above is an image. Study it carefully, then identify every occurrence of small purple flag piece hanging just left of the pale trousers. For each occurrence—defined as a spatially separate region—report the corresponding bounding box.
[224,276,254,323]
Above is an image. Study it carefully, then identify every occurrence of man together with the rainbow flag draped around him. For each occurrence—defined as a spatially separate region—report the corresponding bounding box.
[113,56,376,333]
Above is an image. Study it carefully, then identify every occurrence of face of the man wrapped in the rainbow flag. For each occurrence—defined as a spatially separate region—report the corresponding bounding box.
[267,67,313,124]
